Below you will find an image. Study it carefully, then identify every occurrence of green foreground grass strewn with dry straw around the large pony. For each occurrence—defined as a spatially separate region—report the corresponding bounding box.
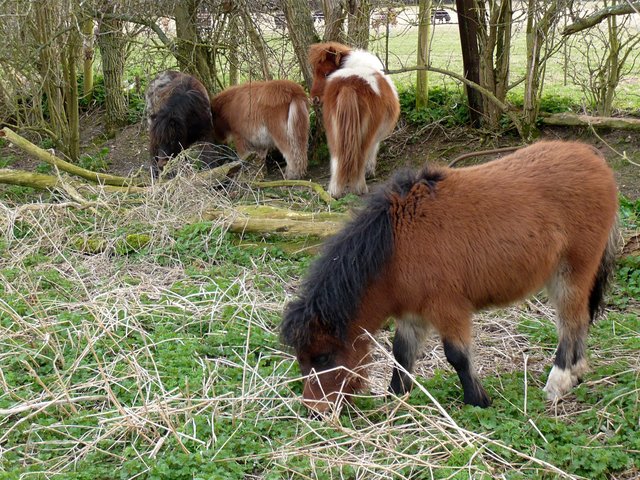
[0,172,640,480]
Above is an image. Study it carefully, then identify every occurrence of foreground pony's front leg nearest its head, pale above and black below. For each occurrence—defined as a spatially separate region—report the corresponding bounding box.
[389,317,427,395]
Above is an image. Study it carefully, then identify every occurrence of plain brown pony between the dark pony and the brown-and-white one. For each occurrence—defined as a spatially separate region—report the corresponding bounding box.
[211,80,309,179]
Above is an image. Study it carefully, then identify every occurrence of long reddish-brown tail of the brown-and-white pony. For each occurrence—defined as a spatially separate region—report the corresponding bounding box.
[334,86,364,186]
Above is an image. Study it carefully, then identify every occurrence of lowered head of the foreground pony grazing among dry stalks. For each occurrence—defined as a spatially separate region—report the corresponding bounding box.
[281,300,369,413]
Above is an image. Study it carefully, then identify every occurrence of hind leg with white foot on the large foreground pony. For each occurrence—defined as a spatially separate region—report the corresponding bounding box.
[544,273,590,401]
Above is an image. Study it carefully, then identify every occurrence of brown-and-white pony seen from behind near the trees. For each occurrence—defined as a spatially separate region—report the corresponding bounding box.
[309,42,400,197]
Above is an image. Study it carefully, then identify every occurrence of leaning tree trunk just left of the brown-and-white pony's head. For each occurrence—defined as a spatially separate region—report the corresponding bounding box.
[280,0,320,90]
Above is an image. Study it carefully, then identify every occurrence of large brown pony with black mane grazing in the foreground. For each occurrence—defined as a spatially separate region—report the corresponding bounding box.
[281,141,617,411]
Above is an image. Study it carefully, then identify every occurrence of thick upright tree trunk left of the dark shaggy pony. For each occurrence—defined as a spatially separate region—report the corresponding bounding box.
[97,11,128,136]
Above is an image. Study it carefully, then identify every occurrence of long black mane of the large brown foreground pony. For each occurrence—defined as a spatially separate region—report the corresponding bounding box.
[280,167,443,350]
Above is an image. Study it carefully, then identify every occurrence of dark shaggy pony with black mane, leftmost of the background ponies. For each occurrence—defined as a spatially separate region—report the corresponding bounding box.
[145,70,213,177]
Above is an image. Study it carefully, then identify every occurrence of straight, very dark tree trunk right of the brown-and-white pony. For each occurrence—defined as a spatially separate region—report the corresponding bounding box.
[456,0,484,127]
